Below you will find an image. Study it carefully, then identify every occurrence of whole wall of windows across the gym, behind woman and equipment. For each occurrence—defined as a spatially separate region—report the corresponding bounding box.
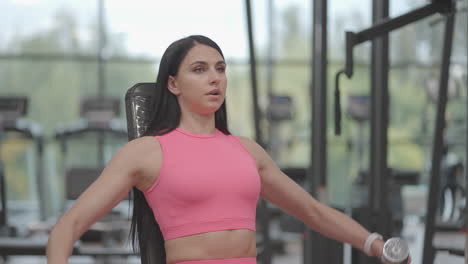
[0,0,467,225]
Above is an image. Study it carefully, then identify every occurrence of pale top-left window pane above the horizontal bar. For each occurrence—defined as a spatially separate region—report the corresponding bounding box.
[0,0,97,54]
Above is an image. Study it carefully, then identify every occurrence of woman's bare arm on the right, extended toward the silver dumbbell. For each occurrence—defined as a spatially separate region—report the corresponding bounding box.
[240,138,384,257]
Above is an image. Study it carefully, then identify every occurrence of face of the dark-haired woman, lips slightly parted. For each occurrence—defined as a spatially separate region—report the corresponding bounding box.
[168,44,227,114]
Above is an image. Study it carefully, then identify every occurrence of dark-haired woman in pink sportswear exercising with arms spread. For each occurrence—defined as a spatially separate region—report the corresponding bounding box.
[47,36,394,264]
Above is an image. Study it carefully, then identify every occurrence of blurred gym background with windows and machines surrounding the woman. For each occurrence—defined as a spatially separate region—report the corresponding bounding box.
[0,0,468,264]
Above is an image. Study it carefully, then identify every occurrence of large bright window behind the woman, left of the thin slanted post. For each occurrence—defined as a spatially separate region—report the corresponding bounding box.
[0,0,253,220]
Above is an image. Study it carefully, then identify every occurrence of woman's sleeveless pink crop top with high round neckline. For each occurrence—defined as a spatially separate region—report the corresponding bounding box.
[144,129,260,240]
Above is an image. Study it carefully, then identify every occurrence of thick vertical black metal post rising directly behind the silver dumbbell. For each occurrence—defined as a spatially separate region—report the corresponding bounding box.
[366,0,392,243]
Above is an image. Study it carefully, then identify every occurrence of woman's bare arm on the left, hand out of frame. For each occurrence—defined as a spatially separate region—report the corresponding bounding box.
[47,137,161,264]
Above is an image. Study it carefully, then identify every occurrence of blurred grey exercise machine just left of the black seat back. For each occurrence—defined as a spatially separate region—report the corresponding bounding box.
[55,96,129,246]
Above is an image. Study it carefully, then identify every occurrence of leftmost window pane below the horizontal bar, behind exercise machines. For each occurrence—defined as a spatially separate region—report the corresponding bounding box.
[0,60,97,219]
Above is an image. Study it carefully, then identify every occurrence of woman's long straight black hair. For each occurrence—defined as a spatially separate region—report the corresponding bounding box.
[130,35,230,264]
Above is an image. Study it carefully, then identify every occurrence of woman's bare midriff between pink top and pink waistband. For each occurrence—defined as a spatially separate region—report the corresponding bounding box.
[165,229,257,264]
